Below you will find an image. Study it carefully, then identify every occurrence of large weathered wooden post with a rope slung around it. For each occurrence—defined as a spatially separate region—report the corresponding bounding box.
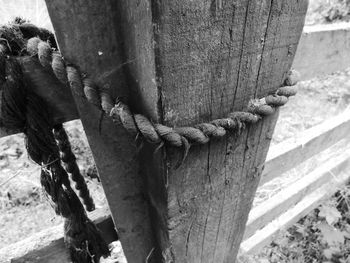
[46,0,308,263]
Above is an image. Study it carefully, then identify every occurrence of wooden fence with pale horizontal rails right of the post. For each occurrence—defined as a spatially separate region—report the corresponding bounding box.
[241,23,350,253]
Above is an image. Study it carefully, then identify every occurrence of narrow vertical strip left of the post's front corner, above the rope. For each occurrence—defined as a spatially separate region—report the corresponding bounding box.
[115,0,161,122]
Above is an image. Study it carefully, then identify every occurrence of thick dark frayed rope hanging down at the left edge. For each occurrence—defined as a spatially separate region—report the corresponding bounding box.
[0,21,109,263]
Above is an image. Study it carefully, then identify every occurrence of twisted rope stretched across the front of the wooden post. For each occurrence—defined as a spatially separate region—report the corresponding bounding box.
[27,33,300,165]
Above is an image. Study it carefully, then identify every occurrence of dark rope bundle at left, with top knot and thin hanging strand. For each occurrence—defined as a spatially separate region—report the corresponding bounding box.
[0,19,109,263]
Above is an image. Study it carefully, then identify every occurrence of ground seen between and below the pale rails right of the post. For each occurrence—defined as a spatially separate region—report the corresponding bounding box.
[240,70,350,263]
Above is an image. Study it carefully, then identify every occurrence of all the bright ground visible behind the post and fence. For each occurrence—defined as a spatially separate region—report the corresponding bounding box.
[0,0,350,263]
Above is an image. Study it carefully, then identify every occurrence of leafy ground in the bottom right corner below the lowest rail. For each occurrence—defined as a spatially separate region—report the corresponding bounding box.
[259,186,350,263]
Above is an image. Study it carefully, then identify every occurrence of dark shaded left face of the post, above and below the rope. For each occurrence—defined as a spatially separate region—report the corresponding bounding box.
[46,0,153,263]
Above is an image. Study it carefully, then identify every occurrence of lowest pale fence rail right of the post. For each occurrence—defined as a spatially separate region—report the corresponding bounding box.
[241,151,350,254]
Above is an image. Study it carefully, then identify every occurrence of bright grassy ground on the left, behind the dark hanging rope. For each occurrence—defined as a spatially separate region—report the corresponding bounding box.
[0,121,106,248]
